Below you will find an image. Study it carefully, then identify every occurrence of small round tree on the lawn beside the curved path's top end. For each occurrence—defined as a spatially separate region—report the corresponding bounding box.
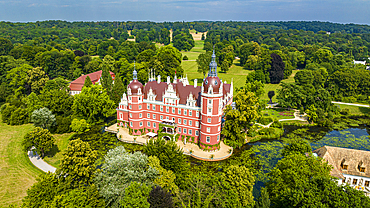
[22,127,55,157]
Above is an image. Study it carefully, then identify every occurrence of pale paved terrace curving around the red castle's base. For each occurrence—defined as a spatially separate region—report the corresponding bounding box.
[106,124,233,161]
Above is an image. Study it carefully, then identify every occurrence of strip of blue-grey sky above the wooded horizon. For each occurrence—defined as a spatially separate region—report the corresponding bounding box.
[0,0,370,24]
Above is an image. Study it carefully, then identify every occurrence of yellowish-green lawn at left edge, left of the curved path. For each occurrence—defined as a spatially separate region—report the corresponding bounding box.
[0,122,43,207]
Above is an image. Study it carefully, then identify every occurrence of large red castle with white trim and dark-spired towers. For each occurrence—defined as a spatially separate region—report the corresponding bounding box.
[117,52,233,150]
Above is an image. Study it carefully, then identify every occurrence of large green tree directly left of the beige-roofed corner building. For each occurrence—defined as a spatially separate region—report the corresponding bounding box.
[267,154,331,207]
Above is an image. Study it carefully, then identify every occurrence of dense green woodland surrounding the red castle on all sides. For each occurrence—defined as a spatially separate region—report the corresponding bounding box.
[0,21,370,208]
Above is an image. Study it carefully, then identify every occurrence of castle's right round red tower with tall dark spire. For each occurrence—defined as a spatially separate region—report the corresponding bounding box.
[200,50,223,148]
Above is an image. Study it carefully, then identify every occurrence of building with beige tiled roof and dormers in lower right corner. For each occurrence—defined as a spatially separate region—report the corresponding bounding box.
[313,146,370,196]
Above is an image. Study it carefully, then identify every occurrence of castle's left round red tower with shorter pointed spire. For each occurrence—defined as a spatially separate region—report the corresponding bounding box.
[127,65,144,135]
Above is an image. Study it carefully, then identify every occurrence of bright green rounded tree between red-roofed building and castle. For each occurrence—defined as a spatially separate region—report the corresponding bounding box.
[72,85,116,124]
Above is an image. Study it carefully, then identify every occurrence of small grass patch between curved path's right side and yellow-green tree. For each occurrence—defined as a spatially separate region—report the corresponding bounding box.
[44,133,74,168]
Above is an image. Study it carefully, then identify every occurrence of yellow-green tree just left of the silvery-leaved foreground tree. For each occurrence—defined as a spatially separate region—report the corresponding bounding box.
[56,139,98,187]
